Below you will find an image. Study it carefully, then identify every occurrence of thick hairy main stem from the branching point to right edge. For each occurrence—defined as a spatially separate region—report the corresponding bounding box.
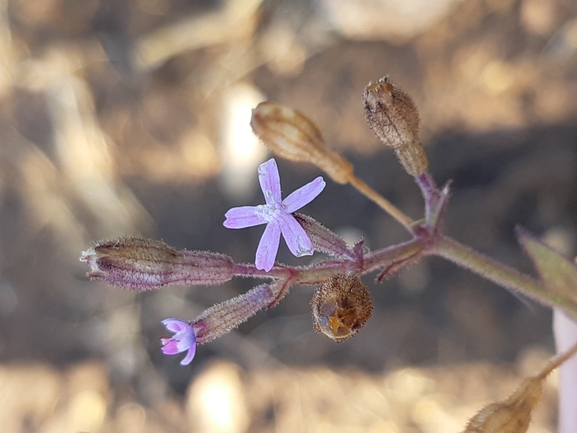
[427,236,577,313]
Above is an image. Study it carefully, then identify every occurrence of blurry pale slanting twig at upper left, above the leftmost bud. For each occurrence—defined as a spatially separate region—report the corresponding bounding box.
[46,46,150,234]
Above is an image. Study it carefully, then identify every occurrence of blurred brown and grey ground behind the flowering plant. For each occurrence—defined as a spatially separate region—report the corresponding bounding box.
[0,0,577,433]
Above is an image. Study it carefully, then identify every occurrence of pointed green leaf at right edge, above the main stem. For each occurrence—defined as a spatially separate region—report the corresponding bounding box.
[517,228,577,303]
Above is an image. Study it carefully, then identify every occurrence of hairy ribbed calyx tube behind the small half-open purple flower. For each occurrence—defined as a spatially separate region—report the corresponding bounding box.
[190,284,277,344]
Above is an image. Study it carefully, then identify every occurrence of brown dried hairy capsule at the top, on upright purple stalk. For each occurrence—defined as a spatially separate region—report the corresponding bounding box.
[363,77,428,176]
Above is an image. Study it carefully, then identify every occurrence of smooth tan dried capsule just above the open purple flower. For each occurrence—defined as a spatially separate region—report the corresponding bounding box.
[250,102,353,184]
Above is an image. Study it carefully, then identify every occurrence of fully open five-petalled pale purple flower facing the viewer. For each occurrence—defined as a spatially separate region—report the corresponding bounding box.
[224,158,326,272]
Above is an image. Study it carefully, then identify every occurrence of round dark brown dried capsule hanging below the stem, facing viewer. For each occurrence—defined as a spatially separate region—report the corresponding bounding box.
[311,274,373,341]
